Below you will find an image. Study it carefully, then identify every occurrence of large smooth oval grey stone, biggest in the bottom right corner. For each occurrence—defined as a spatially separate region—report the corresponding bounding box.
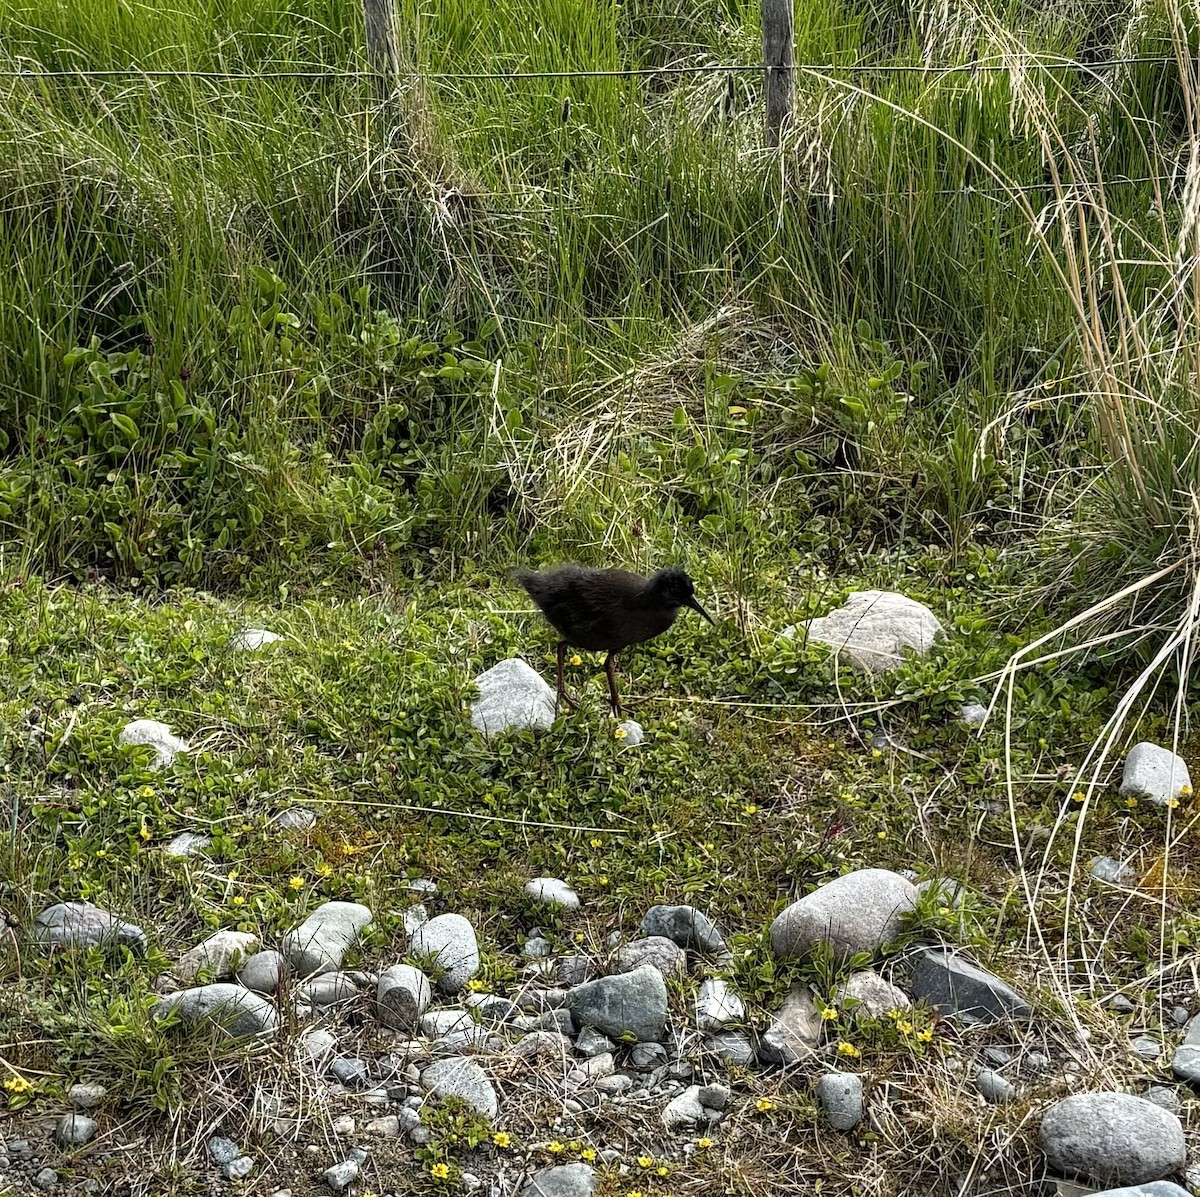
[1039,1093,1187,1185]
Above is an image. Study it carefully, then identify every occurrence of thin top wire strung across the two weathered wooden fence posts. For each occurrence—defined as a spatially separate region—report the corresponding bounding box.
[0,55,1178,83]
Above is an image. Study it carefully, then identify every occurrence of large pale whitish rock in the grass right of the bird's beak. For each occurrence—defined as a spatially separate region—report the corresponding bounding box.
[806,590,942,673]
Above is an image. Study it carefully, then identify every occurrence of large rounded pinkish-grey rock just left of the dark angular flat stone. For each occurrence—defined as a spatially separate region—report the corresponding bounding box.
[770,868,917,960]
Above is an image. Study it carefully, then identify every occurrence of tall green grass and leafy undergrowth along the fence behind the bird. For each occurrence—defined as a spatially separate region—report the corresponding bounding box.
[0,0,1187,597]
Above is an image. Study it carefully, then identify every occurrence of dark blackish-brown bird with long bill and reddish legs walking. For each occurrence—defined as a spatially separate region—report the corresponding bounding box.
[512,565,716,715]
